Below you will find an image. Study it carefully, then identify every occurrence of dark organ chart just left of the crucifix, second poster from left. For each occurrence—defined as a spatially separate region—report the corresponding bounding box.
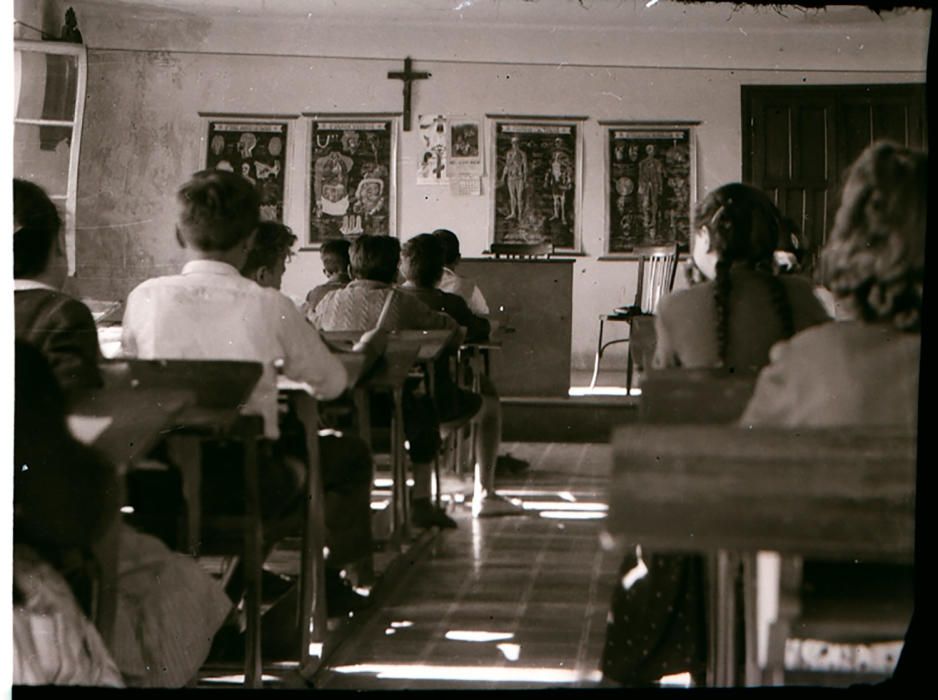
[306,114,397,248]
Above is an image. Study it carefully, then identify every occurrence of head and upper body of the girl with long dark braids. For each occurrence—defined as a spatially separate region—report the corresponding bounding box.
[655,182,830,371]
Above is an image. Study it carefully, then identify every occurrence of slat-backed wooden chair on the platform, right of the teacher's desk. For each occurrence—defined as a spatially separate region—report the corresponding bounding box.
[590,243,678,393]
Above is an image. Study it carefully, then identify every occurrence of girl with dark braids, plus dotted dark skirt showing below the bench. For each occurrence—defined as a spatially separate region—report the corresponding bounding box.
[602,183,829,686]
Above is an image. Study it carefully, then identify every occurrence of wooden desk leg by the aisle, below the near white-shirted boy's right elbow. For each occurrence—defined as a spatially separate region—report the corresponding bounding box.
[294,394,328,679]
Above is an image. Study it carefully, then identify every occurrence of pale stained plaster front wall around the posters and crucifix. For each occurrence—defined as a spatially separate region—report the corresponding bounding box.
[60,0,929,368]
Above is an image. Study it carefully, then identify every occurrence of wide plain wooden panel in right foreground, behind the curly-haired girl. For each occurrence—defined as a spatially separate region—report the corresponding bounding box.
[606,424,916,562]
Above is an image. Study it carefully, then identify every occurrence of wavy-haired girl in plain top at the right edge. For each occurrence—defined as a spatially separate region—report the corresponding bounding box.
[740,141,928,680]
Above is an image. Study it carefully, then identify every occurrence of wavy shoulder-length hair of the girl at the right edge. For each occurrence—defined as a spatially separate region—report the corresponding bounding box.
[821,141,928,331]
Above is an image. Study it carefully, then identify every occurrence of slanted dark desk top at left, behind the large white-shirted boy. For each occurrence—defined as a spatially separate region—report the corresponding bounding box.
[70,388,195,473]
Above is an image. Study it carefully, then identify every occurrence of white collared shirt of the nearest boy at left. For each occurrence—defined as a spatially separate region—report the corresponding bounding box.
[122,260,348,439]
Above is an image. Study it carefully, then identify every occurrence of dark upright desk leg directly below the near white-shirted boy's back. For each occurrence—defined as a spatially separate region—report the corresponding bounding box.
[244,434,264,688]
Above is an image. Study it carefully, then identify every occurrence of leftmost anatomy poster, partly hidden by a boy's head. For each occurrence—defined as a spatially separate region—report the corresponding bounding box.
[205,121,287,222]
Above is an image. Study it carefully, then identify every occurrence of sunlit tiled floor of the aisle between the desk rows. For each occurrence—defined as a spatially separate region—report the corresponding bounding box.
[315,443,618,690]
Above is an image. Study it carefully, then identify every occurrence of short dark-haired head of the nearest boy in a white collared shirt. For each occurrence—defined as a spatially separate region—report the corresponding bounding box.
[176,170,260,251]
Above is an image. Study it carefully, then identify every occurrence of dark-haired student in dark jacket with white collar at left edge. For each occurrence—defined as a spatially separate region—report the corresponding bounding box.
[13,179,102,400]
